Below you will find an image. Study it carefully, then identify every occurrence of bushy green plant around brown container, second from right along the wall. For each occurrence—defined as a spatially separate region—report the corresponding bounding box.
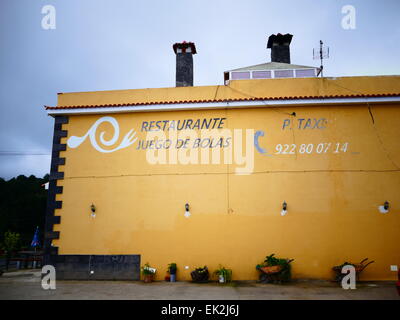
[256,254,293,283]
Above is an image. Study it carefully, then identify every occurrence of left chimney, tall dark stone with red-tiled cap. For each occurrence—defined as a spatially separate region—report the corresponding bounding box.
[172,41,197,87]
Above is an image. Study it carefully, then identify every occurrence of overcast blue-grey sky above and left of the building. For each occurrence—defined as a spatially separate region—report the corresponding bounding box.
[0,0,400,179]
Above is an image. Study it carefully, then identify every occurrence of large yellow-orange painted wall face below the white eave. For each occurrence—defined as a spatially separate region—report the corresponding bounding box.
[53,102,400,280]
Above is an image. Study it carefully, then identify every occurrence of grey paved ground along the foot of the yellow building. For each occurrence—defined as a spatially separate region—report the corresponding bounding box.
[0,270,400,300]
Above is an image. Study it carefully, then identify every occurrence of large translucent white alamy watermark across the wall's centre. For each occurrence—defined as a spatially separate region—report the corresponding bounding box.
[145,129,254,174]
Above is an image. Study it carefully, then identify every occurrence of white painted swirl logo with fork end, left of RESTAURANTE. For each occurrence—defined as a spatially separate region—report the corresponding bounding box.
[67,117,137,153]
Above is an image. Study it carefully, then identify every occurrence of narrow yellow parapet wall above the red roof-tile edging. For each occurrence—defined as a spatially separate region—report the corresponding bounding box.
[58,76,400,106]
